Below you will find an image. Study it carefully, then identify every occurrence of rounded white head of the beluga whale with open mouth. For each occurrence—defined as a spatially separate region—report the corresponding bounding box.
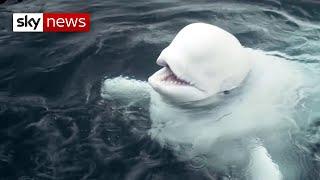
[148,23,250,103]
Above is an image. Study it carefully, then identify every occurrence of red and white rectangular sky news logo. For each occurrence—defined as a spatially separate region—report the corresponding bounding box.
[12,13,90,32]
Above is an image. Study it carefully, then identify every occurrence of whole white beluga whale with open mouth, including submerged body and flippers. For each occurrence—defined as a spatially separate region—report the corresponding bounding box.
[101,23,304,180]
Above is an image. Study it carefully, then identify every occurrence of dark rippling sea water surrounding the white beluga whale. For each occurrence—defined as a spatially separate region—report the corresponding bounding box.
[0,0,320,180]
